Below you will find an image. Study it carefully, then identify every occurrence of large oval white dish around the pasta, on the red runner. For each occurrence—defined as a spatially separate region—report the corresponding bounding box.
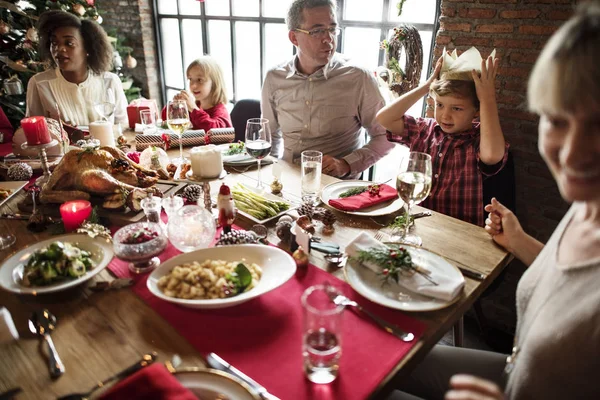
[147,244,296,308]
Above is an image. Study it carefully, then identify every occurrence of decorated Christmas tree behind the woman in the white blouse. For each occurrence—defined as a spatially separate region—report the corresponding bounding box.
[0,0,141,128]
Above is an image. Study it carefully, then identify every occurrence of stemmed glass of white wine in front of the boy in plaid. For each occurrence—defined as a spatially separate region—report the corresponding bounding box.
[396,152,431,246]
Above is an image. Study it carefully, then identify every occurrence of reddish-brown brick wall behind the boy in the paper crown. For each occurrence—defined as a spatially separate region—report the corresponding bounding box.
[434,0,578,332]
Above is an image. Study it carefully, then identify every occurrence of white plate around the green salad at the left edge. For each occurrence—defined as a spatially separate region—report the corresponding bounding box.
[0,233,113,295]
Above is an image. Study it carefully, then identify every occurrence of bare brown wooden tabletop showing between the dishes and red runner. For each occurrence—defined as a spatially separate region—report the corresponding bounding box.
[0,143,512,399]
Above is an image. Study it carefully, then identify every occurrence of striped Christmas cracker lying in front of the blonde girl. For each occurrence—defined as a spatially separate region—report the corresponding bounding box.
[135,128,235,151]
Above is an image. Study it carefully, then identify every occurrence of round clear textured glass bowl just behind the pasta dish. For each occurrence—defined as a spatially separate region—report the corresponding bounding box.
[167,205,217,253]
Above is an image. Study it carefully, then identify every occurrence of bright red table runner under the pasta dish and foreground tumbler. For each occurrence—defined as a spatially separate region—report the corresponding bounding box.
[108,227,425,400]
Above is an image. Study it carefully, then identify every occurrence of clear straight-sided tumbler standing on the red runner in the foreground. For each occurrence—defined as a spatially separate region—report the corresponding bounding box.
[301,285,344,383]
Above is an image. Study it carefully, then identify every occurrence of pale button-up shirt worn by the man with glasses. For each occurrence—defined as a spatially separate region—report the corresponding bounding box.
[261,53,394,177]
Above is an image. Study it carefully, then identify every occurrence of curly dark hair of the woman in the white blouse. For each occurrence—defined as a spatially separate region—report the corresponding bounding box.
[37,10,113,74]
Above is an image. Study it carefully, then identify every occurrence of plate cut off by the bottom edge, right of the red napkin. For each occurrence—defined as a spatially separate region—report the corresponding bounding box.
[173,368,260,400]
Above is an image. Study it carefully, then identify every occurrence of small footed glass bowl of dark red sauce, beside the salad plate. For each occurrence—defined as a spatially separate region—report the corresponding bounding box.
[113,222,168,274]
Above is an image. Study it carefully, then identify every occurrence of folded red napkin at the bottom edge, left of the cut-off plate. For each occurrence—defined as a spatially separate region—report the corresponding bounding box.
[100,364,197,400]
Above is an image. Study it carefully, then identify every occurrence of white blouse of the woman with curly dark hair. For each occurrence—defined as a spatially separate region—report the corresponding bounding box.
[26,68,127,125]
